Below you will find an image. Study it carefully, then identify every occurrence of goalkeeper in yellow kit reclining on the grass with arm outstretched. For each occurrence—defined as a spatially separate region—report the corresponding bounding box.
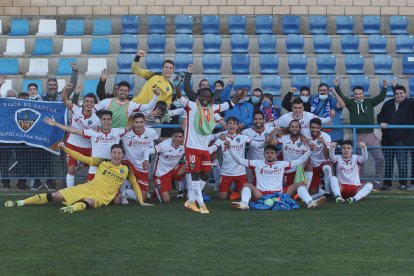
[5,143,151,213]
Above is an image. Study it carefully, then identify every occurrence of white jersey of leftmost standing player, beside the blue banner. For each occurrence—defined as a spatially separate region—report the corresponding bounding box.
[67,104,100,148]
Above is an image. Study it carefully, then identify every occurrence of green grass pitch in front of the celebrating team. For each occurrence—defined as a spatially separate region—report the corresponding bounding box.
[0,193,414,275]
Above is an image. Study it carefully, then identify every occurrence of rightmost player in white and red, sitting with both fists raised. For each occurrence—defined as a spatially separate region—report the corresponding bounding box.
[329,140,373,203]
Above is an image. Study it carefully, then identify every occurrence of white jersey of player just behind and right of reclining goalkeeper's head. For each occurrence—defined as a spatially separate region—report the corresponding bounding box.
[122,127,159,171]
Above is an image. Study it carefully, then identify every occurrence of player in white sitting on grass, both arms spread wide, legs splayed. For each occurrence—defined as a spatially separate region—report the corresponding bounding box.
[225,142,326,210]
